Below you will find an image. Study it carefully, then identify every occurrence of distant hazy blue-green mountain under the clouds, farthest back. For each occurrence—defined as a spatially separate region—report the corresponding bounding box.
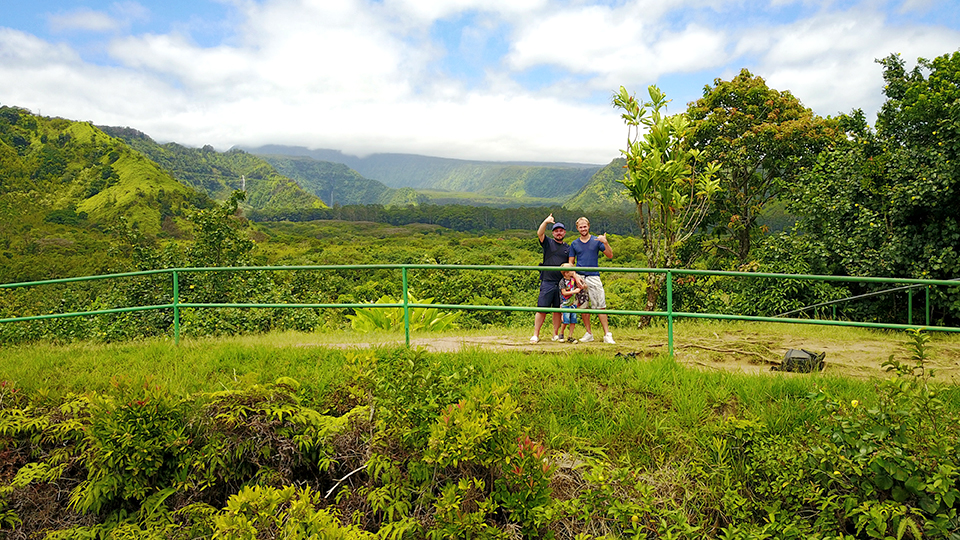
[247,145,600,201]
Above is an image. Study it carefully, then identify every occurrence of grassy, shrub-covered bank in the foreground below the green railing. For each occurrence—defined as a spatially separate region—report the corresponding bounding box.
[0,323,960,539]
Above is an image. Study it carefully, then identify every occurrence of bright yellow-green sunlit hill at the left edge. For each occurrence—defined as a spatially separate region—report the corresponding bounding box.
[0,106,212,282]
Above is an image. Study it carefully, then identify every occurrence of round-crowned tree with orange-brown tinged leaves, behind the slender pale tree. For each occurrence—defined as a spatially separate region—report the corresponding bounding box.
[687,69,842,264]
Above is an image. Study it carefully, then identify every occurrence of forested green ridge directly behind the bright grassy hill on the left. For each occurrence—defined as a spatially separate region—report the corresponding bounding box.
[100,126,326,209]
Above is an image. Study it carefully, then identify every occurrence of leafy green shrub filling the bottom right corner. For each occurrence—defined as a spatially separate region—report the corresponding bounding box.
[811,330,960,538]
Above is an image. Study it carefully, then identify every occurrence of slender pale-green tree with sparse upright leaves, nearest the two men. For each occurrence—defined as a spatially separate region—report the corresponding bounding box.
[613,85,720,326]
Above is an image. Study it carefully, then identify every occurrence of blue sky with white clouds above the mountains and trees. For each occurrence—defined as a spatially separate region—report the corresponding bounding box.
[0,0,960,164]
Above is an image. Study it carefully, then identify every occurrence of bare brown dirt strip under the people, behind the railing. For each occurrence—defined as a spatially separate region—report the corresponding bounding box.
[326,329,960,384]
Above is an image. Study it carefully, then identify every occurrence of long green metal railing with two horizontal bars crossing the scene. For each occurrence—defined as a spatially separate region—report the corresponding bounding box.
[0,264,960,356]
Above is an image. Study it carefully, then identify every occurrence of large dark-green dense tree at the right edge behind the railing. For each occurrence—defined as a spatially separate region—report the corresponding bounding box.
[789,53,960,320]
